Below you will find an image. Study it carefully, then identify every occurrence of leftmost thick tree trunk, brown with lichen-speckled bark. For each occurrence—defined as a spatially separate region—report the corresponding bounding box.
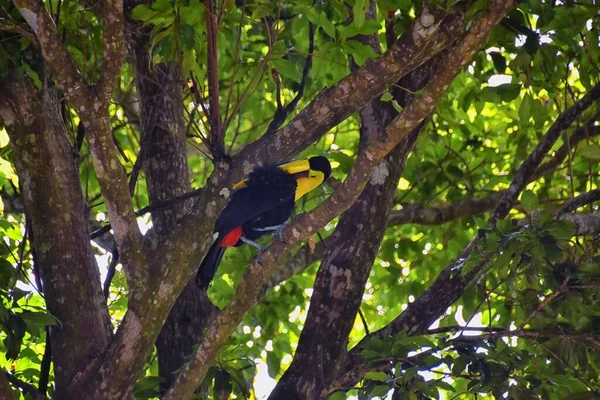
[0,68,112,398]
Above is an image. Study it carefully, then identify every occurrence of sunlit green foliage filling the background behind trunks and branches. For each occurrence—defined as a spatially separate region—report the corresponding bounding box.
[0,0,600,399]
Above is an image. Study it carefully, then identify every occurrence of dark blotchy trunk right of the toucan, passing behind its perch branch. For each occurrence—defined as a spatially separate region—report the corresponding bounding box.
[270,2,446,394]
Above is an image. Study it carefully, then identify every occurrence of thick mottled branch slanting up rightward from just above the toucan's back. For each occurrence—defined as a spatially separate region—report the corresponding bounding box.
[234,2,466,173]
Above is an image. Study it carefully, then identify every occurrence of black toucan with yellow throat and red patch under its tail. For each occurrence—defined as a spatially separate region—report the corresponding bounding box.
[196,156,331,289]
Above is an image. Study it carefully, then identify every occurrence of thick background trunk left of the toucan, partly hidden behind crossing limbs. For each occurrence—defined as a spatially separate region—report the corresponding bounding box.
[127,1,215,389]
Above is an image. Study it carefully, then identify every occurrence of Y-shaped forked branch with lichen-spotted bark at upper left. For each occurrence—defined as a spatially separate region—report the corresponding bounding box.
[15,0,145,289]
